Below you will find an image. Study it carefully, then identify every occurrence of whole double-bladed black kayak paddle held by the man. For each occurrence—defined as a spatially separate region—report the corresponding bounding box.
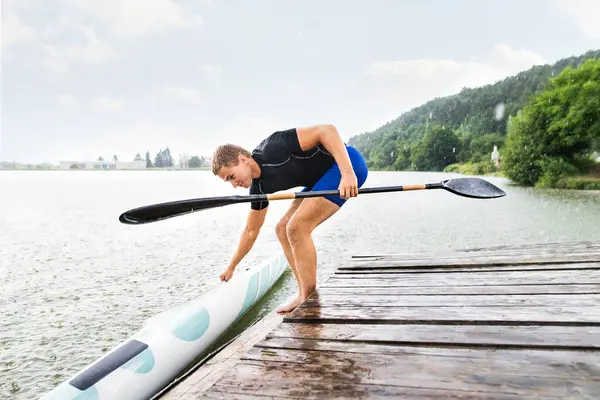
[119,178,506,225]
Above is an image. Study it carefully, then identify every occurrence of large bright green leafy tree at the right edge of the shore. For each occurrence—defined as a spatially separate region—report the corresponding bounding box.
[503,60,600,187]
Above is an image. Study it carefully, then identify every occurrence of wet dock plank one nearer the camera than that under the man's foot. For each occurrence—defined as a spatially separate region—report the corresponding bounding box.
[265,322,600,350]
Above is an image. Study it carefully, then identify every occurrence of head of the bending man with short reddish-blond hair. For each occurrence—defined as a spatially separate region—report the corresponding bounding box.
[212,143,260,188]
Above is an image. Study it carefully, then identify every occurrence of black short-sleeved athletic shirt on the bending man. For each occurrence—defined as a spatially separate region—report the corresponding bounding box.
[250,128,335,210]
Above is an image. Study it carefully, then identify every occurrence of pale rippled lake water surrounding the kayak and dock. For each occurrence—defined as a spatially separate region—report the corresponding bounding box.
[0,171,600,399]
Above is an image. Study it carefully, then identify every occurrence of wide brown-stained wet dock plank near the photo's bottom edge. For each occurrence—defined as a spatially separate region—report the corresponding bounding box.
[203,340,600,398]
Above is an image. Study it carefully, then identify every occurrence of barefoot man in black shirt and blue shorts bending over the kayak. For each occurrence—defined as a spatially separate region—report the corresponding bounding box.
[212,125,368,313]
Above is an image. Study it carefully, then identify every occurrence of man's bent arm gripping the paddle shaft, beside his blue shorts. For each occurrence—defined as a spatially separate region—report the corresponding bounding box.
[296,124,358,198]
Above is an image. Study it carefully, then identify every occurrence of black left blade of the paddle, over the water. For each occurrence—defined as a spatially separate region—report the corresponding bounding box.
[119,196,238,225]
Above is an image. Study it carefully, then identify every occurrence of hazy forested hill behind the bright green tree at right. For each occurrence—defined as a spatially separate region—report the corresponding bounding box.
[348,50,600,170]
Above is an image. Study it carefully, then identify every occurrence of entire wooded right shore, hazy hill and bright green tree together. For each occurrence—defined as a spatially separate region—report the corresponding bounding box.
[349,51,600,186]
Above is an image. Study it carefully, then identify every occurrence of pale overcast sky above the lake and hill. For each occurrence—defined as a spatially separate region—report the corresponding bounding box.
[0,0,600,163]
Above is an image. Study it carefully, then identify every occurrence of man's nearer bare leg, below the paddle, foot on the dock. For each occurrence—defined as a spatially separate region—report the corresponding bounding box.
[277,197,340,312]
